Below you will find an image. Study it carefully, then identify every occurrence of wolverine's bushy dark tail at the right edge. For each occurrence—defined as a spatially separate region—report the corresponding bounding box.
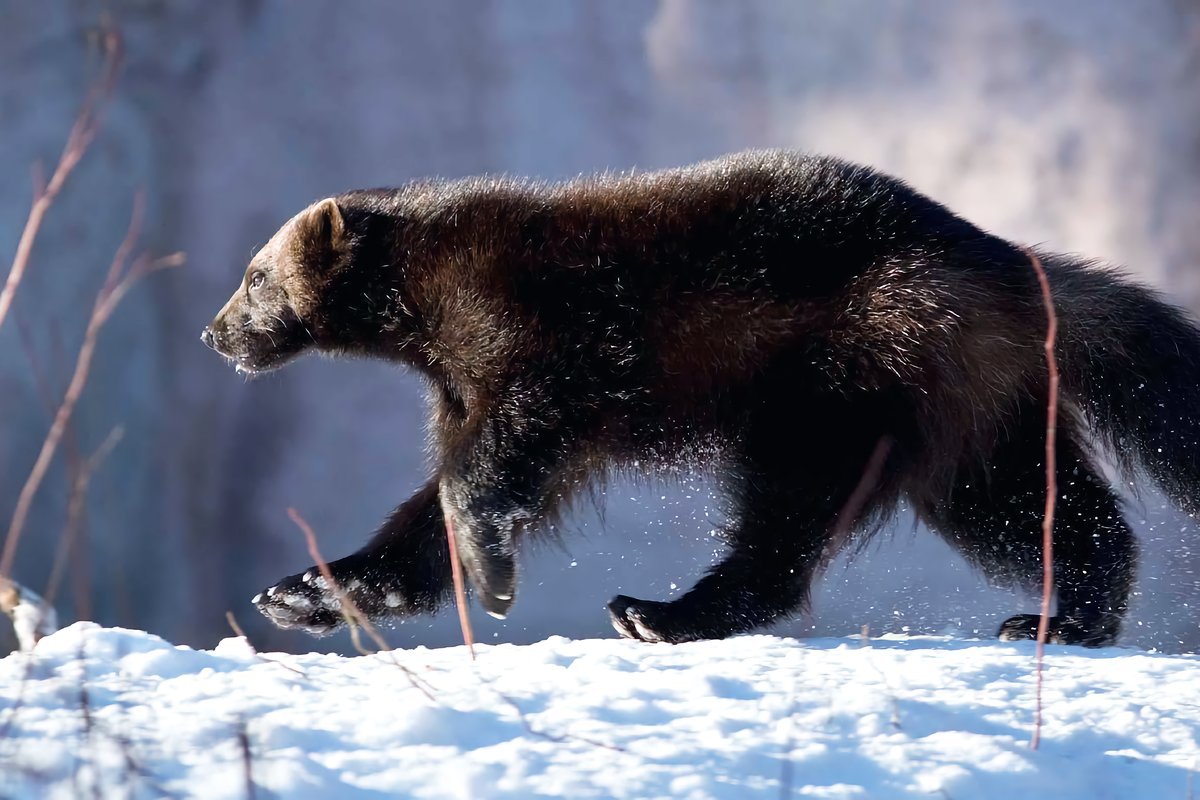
[1045,257,1200,513]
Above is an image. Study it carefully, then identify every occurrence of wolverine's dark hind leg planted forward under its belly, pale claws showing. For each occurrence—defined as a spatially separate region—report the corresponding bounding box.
[608,393,890,642]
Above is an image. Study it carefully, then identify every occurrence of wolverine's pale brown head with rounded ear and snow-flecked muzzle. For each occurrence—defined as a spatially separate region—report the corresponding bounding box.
[200,199,349,374]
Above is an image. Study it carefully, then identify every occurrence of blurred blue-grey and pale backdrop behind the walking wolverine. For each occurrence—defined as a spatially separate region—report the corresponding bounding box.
[0,0,1200,651]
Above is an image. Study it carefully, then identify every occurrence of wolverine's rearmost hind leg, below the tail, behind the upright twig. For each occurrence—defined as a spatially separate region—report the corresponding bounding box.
[931,405,1136,646]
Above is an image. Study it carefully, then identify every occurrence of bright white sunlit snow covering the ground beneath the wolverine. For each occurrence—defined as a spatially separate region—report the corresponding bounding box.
[0,622,1200,800]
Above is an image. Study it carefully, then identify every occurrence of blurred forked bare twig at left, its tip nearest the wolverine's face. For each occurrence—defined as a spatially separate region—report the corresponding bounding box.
[0,193,184,577]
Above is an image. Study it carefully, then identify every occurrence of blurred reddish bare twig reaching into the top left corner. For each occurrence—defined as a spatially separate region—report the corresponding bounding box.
[0,28,124,327]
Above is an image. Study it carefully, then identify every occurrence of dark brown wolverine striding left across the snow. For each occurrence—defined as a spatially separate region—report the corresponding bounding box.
[203,151,1200,646]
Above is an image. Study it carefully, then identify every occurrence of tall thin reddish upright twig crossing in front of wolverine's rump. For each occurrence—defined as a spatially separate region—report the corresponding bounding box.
[1025,249,1058,750]
